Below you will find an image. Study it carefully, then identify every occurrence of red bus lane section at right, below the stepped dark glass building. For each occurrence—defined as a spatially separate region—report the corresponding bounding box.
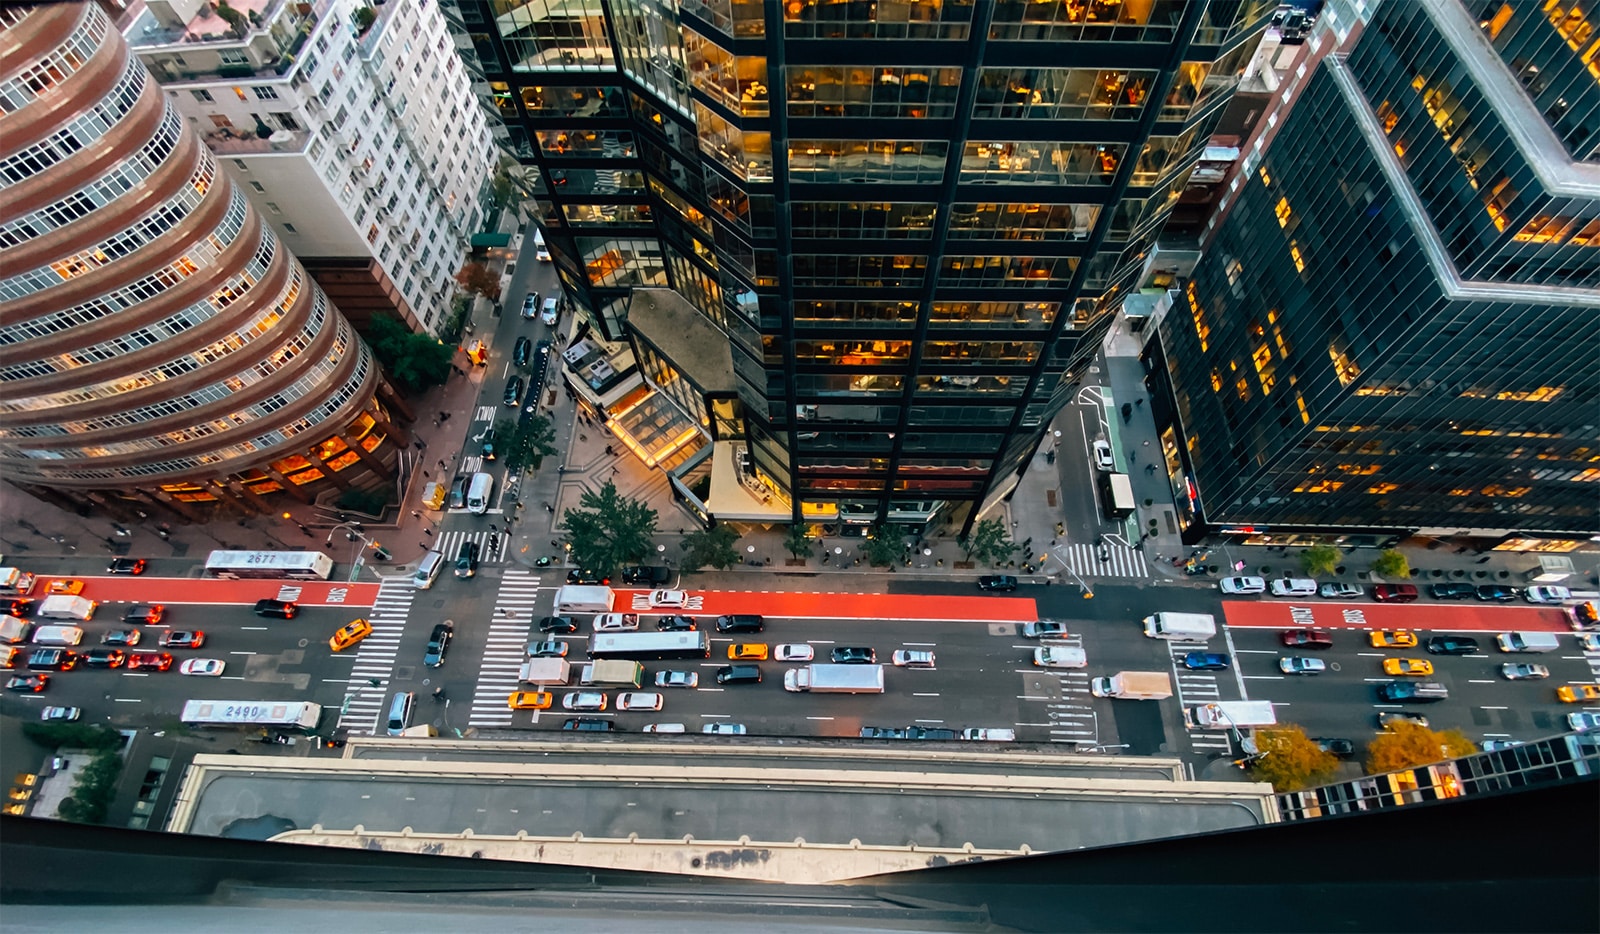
[1222,600,1573,632]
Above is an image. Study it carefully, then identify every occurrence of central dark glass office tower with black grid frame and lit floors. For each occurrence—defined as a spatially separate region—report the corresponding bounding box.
[453,0,1272,529]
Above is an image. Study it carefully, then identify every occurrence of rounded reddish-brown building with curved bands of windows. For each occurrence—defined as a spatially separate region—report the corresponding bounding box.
[0,3,410,518]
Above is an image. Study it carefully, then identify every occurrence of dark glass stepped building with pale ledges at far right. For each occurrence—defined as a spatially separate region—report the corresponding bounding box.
[1147,0,1600,549]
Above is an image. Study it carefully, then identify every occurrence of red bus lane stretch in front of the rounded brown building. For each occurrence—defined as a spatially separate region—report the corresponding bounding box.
[29,574,378,609]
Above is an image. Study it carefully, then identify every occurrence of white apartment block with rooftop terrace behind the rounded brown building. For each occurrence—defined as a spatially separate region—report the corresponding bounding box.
[125,0,499,333]
